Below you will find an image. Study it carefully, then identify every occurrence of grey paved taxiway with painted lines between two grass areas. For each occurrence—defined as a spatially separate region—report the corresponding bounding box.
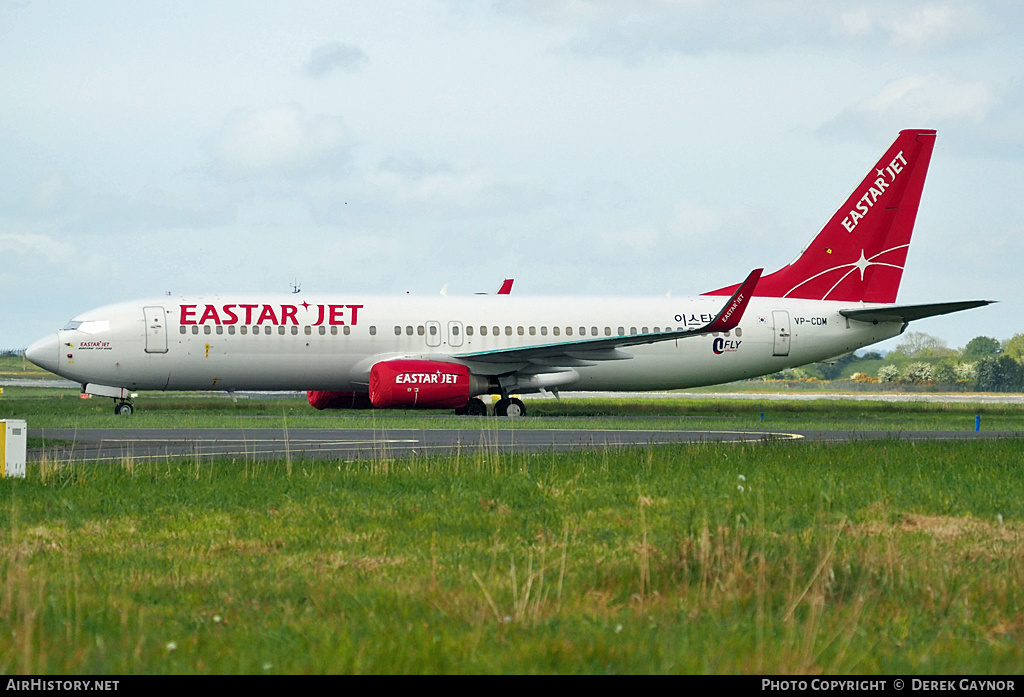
[28,429,1024,463]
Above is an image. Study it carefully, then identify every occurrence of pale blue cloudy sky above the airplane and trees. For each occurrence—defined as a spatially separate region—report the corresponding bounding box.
[0,0,1024,349]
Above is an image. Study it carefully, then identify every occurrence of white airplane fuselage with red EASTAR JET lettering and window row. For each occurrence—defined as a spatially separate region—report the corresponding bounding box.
[30,295,903,391]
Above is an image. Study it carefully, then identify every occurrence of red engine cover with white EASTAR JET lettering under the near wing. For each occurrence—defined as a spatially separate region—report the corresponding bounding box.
[370,360,469,409]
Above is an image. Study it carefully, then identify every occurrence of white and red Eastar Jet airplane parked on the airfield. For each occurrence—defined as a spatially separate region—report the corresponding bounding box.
[26,129,991,417]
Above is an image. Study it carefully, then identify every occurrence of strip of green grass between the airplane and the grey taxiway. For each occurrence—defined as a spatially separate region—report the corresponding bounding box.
[0,388,1024,431]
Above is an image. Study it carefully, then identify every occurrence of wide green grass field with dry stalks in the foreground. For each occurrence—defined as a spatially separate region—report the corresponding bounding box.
[0,440,1024,674]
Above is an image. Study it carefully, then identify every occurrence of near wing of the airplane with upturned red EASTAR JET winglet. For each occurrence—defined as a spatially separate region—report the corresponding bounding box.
[453,268,764,366]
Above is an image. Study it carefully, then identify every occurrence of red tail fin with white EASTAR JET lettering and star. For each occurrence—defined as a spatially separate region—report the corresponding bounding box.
[705,129,935,303]
